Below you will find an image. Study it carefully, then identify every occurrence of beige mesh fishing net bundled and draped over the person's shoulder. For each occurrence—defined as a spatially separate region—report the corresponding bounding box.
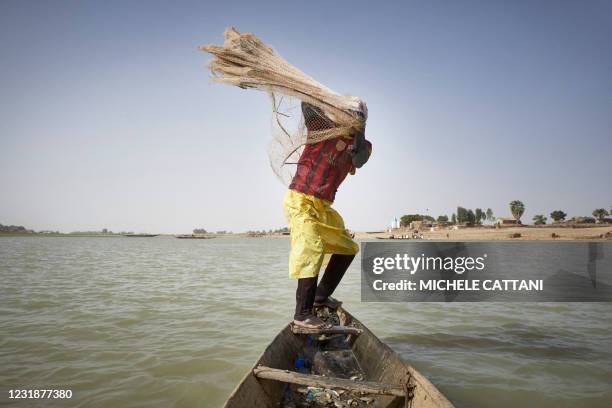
[200,27,367,185]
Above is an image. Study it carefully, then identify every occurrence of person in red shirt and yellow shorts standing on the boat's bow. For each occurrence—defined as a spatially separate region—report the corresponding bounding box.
[284,102,372,329]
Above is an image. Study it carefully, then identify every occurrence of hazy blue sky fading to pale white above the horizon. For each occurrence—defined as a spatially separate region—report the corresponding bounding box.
[0,0,612,232]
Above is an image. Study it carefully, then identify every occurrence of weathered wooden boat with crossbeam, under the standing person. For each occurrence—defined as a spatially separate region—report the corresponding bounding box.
[225,308,453,408]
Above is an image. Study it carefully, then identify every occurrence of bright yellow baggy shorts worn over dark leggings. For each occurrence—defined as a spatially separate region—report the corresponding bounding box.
[284,190,359,279]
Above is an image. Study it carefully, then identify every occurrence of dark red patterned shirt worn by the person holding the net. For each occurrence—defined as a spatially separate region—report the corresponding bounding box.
[289,113,371,202]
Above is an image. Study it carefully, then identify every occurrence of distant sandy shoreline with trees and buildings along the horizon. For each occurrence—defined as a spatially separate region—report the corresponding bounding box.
[0,200,612,241]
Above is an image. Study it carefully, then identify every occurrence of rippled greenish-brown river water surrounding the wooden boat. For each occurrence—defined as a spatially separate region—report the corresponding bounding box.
[0,237,612,408]
